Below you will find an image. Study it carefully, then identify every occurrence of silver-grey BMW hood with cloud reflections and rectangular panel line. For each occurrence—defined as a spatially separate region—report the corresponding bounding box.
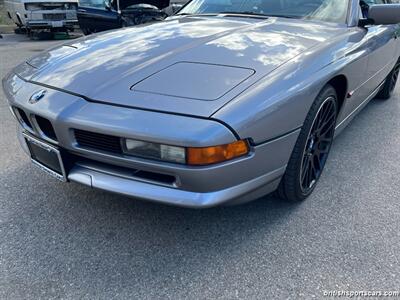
[17,17,343,117]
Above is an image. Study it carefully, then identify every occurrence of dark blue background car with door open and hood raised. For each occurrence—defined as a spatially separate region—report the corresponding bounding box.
[78,0,169,34]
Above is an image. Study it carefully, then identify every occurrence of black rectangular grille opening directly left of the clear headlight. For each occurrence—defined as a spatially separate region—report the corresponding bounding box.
[74,129,122,154]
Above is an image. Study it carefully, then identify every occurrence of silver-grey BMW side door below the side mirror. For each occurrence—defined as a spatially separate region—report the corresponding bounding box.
[365,0,397,93]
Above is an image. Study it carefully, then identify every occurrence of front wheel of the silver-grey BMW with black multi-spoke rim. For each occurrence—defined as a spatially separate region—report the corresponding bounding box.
[277,85,338,202]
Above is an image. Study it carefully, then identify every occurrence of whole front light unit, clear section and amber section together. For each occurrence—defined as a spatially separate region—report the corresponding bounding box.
[123,139,250,166]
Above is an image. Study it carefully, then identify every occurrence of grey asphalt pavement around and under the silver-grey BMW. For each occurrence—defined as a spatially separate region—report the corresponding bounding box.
[0,35,400,299]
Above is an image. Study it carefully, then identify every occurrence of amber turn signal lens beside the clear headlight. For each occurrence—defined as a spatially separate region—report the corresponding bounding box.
[187,140,249,165]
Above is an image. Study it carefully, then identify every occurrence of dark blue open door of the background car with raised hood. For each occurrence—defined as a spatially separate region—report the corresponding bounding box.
[78,0,120,33]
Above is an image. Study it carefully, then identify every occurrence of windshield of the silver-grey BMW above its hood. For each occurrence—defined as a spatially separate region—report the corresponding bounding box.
[178,0,349,23]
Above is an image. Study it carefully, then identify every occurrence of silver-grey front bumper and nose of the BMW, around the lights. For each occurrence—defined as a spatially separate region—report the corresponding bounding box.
[4,76,298,208]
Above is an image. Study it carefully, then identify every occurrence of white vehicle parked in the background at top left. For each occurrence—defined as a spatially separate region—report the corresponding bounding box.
[4,0,78,31]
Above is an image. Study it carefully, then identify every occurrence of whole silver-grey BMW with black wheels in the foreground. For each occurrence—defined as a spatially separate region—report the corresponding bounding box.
[3,0,400,208]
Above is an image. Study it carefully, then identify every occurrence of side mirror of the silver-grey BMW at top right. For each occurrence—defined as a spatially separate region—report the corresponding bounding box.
[368,4,400,25]
